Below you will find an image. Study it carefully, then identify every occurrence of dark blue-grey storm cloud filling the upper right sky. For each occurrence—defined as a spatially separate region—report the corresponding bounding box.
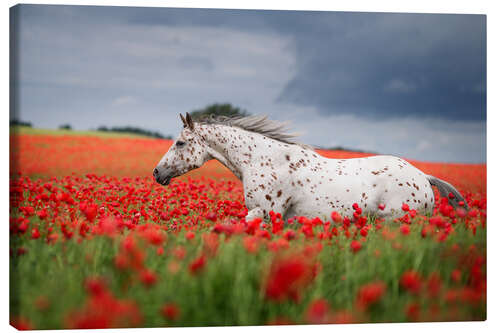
[128,9,486,120]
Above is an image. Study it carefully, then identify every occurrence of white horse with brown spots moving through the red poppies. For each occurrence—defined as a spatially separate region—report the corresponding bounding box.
[153,113,468,221]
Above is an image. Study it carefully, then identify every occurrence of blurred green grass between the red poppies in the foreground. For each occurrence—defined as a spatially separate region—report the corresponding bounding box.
[10,214,485,329]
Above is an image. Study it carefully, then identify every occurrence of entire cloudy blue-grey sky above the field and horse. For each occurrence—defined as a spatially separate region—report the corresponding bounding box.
[11,5,486,163]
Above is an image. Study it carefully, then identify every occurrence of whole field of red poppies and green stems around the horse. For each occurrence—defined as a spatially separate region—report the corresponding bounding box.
[9,128,487,329]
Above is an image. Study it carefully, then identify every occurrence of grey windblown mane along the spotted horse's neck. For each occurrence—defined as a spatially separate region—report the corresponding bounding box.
[195,115,313,150]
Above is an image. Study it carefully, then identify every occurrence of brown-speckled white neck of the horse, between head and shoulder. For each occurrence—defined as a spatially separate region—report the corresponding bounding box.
[200,124,283,180]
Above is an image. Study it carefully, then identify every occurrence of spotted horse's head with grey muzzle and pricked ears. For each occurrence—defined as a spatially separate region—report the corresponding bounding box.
[153,113,210,185]
